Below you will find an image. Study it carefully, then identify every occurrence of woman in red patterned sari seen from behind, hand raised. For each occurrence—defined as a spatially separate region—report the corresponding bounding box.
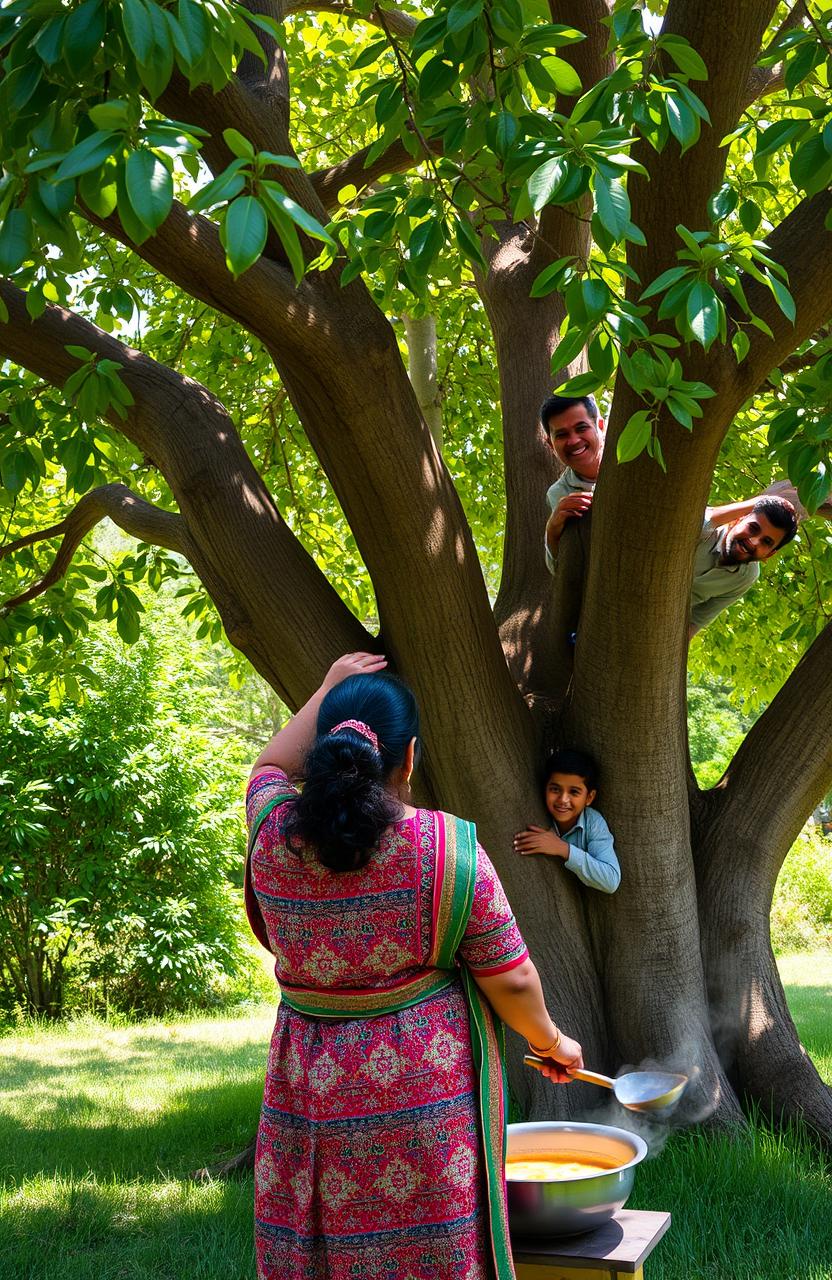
[246,654,582,1280]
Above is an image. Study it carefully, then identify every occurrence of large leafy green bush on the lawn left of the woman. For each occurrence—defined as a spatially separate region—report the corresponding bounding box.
[0,639,257,1018]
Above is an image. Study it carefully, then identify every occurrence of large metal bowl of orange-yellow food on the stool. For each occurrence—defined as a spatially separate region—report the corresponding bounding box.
[507,1120,648,1236]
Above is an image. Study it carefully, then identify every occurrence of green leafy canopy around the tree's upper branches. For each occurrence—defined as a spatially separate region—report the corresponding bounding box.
[0,0,832,698]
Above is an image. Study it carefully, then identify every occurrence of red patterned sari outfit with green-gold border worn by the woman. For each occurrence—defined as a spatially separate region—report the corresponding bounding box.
[247,771,527,1280]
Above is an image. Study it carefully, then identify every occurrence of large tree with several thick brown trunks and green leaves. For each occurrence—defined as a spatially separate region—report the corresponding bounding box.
[0,0,832,1133]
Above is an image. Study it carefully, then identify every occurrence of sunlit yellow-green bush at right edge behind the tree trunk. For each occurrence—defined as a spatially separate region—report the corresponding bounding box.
[772,827,832,952]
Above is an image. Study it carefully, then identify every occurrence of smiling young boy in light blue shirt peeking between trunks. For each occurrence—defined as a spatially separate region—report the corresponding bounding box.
[515,750,621,893]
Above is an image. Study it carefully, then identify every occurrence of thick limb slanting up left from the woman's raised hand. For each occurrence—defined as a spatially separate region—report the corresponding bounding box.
[0,280,374,705]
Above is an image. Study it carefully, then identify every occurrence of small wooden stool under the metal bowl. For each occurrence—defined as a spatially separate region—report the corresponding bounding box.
[512,1208,671,1280]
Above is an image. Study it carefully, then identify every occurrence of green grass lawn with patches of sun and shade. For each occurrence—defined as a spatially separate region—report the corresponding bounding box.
[0,955,832,1280]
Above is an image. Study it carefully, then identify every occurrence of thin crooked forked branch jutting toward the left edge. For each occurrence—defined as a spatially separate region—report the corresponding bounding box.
[0,484,188,609]
